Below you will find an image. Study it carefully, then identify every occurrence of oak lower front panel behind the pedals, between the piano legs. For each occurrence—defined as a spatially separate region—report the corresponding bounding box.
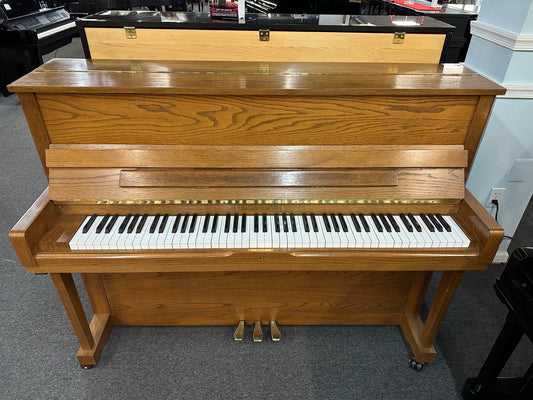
[102,271,414,325]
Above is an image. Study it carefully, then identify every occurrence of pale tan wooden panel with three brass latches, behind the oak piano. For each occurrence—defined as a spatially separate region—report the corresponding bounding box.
[85,27,446,64]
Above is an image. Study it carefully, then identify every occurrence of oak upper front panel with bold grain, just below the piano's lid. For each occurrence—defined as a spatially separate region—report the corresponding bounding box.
[38,94,477,146]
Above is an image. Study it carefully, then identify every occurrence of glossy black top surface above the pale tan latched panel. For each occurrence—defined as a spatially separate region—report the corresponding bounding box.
[77,10,455,33]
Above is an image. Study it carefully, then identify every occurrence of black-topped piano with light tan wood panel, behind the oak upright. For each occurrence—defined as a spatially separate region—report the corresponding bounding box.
[76,10,455,63]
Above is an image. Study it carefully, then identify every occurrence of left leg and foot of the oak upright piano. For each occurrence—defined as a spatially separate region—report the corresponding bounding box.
[50,274,113,368]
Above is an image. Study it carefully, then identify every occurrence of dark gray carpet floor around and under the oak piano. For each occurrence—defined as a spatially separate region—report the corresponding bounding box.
[0,36,533,400]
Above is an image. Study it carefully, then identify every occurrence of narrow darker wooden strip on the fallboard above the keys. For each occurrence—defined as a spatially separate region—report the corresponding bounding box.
[119,168,398,188]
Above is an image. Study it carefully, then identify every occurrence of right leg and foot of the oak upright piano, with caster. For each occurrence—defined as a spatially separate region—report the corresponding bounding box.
[400,271,464,363]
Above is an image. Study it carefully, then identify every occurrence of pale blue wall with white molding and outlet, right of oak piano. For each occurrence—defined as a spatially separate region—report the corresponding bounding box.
[465,0,533,256]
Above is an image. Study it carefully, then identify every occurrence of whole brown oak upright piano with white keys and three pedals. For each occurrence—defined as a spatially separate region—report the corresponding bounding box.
[10,59,505,368]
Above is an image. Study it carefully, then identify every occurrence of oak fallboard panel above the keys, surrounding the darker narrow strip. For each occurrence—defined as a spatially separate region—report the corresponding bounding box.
[50,168,464,200]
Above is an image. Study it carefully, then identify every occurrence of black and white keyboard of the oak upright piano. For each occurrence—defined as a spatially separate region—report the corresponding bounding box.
[69,214,470,250]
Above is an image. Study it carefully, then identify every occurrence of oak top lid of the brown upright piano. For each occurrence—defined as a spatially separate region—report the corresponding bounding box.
[8,59,506,96]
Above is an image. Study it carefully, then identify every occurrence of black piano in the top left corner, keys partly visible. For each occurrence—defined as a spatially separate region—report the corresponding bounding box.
[0,0,78,96]
